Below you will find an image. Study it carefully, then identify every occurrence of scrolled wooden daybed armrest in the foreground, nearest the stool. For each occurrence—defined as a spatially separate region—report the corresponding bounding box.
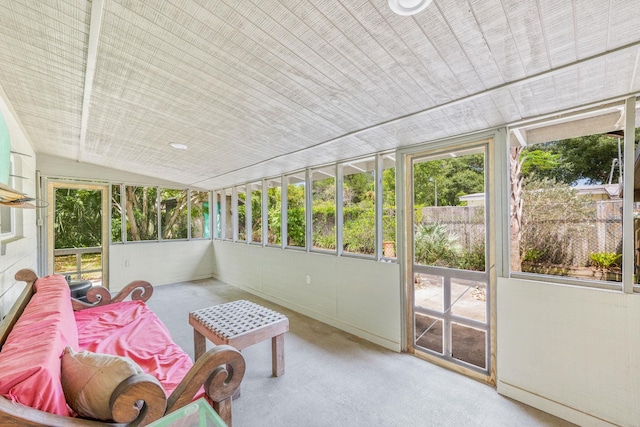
[167,345,245,427]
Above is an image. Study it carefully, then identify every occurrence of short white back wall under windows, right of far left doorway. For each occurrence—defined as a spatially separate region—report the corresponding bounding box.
[109,240,213,291]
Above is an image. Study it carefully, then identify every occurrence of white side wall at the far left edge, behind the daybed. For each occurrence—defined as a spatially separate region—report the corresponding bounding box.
[0,89,38,318]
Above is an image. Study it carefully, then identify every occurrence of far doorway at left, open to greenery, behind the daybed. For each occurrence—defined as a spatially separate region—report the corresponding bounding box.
[47,181,109,288]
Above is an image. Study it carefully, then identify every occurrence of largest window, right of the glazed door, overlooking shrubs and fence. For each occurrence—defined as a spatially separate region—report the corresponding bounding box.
[509,104,638,282]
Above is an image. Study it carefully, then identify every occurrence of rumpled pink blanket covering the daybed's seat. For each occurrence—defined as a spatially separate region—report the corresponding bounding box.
[75,301,193,397]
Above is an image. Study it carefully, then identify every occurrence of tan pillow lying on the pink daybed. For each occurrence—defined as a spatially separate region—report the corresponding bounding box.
[62,347,142,420]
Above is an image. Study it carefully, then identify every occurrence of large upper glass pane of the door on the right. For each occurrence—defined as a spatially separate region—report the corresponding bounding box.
[412,148,486,270]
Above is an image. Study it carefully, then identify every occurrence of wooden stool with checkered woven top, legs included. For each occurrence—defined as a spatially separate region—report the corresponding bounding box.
[189,300,289,377]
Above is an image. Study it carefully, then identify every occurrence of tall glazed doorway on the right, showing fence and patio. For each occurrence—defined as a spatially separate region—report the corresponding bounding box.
[405,141,493,382]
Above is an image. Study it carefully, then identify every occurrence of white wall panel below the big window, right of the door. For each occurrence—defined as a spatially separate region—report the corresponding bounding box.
[497,279,640,426]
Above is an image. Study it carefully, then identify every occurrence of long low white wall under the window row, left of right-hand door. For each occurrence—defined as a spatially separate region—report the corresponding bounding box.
[213,240,401,351]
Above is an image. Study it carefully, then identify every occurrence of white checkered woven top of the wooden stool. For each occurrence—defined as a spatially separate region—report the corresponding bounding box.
[191,300,287,339]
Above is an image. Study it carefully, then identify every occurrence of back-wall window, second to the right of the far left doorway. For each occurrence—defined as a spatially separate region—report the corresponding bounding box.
[125,185,158,242]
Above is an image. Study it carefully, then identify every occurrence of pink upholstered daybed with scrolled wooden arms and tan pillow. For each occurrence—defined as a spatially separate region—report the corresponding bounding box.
[0,270,244,426]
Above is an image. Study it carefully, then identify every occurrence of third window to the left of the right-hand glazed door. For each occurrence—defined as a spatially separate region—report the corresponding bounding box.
[311,165,336,251]
